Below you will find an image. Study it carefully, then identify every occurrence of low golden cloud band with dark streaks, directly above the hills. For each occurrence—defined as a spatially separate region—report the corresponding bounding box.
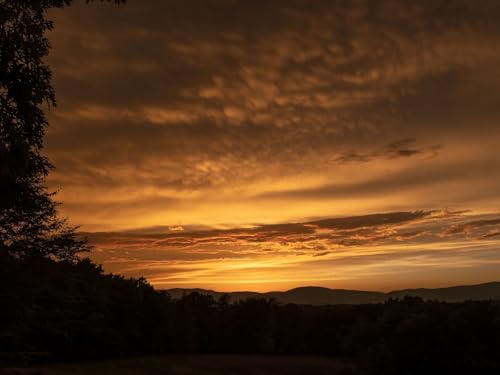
[87,211,500,291]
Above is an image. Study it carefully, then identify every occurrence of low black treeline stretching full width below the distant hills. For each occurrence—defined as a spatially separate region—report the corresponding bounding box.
[0,257,500,374]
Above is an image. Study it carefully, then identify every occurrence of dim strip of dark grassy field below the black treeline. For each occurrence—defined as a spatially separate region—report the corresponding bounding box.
[0,355,356,375]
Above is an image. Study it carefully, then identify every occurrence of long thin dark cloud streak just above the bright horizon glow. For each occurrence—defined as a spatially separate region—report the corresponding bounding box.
[82,211,432,250]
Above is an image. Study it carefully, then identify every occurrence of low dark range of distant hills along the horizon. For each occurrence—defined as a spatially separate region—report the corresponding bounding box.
[166,282,500,305]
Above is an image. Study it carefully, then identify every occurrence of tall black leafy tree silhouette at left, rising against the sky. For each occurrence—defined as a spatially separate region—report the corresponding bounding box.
[0,0,123,260]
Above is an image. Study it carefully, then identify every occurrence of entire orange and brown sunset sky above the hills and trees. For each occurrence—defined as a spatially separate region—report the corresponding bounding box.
[45,0,500,291]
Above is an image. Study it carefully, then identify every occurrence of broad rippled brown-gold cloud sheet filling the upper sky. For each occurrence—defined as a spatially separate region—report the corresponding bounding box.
[42,0,500,241]
